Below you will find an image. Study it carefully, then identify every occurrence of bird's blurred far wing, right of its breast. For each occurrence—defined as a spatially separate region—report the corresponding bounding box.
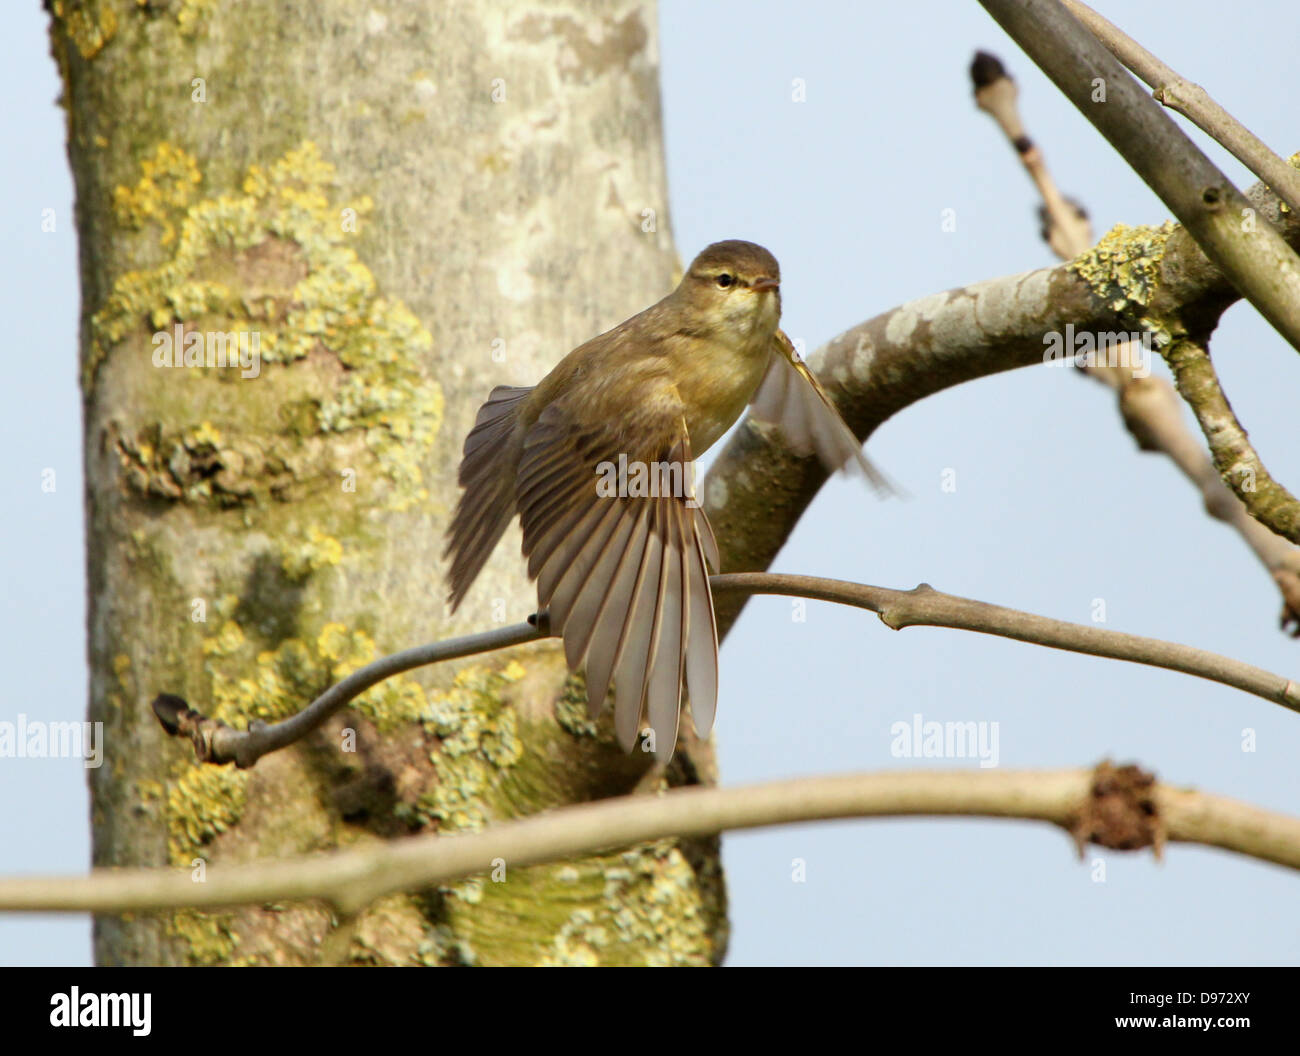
[750,330,897,492]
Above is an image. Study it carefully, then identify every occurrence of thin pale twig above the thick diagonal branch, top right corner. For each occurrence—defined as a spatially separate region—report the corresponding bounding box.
[1062,0,1300,217]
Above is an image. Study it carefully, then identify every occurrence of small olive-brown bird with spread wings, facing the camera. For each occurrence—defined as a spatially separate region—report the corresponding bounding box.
[447,241,888,759]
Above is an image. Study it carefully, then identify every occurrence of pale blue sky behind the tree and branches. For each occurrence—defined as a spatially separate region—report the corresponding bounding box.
[0,0,1300,965]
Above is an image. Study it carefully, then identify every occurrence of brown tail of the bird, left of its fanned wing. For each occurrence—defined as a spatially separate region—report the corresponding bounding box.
[446,385,533,611]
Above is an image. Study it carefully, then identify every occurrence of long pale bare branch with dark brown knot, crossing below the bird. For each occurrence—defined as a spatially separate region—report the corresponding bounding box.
[0,763,1300,916]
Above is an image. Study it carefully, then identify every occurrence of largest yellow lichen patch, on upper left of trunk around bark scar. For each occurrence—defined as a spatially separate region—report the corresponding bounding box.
[82,143,443,511]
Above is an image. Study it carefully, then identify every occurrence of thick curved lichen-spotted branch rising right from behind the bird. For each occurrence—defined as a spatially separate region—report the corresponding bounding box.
[701,166,1300,635]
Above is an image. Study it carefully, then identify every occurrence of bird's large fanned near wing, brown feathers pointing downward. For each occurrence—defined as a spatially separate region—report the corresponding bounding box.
[516,381,718,758]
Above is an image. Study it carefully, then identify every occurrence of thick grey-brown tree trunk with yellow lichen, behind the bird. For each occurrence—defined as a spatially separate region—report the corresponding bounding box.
[47,0,727,964]
